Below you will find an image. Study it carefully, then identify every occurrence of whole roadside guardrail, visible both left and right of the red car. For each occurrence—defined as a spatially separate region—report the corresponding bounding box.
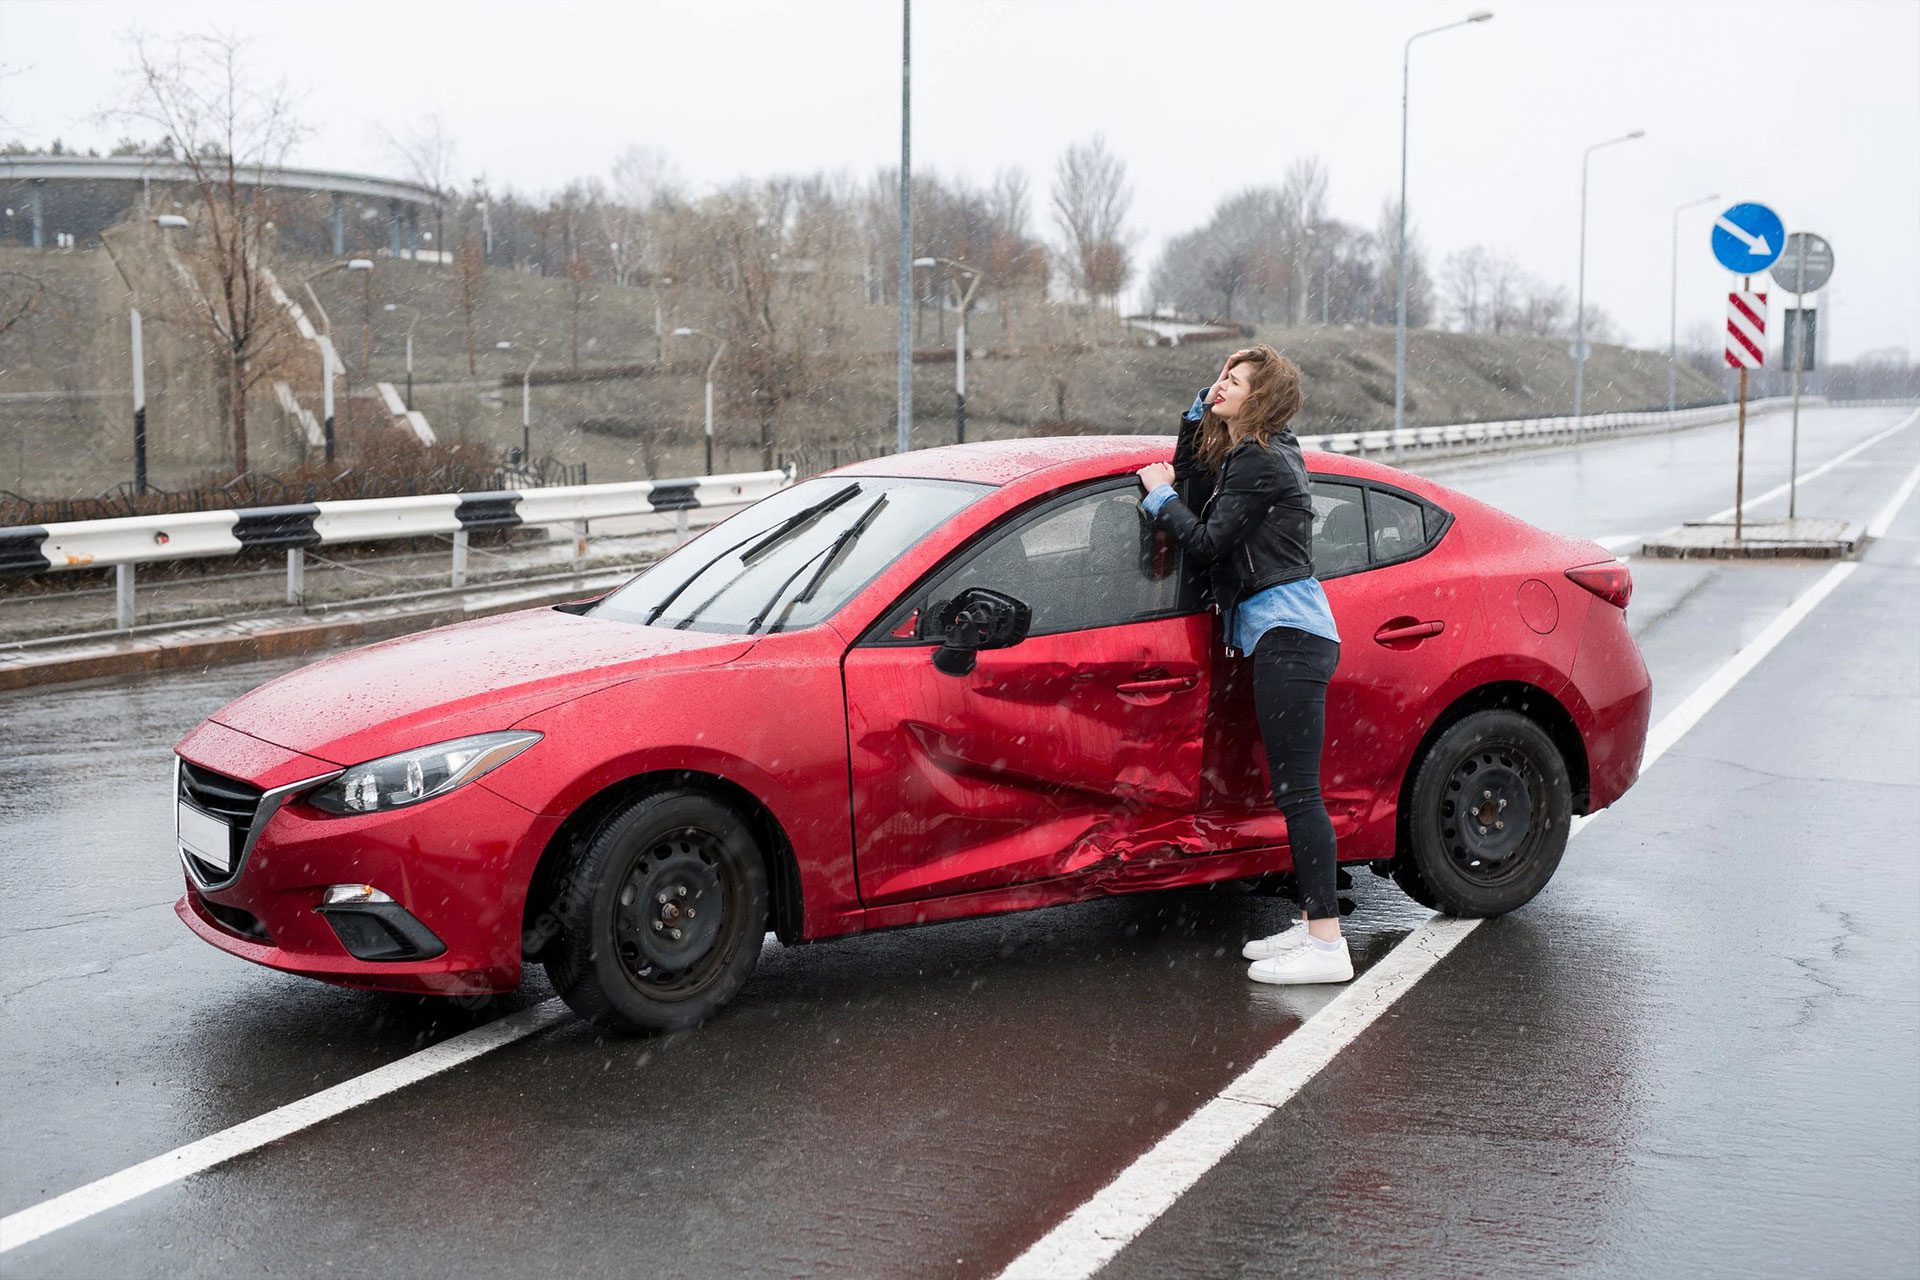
[0,397,1822,631]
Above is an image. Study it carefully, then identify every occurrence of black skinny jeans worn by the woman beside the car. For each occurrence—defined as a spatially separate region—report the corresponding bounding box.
[1254,628,1340,919]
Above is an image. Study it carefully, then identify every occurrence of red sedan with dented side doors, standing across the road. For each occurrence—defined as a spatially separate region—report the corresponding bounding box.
[177,436,1651,1029]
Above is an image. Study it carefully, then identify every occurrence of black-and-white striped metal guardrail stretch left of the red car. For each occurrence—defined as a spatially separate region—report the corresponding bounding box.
[0,470,793,631]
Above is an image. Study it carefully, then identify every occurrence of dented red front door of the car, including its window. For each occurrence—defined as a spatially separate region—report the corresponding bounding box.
[843,476,1212,906]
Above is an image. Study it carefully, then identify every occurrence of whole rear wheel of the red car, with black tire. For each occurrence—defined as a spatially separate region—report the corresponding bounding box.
[1394,710,1572,917]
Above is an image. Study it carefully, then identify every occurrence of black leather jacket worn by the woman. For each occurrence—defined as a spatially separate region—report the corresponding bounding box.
[1154,415,1313,612]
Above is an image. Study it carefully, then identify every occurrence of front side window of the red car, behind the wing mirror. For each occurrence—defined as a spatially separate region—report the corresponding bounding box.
[916,484,1181,635]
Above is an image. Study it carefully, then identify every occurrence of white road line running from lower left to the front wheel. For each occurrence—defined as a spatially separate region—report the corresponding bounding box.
[0,998,568,1253]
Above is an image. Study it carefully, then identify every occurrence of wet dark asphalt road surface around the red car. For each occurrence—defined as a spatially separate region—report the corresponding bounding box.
[0,409,1920,1276]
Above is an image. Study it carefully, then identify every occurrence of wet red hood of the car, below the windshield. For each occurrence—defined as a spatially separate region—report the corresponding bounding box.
[209,608,753,764]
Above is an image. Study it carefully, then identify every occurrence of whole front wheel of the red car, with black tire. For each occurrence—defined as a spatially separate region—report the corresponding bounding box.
[545,791,768,1031]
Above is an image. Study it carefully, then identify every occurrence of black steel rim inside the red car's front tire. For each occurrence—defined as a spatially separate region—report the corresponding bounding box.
[612,827,745,1000]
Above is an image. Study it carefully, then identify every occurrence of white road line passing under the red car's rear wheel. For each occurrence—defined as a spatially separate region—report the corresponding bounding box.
[1000,502,1914,1280]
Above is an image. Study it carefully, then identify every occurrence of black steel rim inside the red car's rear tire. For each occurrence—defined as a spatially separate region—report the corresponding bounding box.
[1434,741,1548,887]
